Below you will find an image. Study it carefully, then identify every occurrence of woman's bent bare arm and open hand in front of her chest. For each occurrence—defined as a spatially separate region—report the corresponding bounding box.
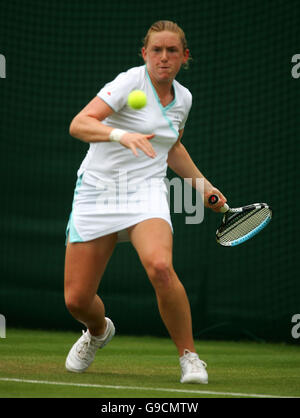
[69,96,156,158]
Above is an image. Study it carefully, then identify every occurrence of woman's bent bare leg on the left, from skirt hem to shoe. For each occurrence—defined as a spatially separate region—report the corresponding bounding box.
[65,234,117,336]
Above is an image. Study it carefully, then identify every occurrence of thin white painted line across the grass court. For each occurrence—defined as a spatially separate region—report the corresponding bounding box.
[0,377,297,398]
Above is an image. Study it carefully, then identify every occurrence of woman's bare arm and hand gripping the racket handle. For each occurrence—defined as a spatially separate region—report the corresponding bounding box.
[167,129,227,212]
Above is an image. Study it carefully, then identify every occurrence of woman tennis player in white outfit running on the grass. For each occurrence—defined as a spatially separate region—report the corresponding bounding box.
[65,21,226,383]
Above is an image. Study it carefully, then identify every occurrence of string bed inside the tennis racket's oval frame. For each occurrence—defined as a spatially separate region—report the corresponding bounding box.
[217,208,271,244]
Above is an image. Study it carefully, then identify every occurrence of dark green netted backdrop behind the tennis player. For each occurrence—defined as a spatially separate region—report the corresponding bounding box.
[0,0,300,342]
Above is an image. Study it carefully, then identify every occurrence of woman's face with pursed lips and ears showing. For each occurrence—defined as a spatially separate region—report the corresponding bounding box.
[142,31,189,83]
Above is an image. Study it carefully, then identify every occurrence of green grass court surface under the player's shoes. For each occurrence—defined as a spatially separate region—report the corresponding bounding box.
[0,329,300,398]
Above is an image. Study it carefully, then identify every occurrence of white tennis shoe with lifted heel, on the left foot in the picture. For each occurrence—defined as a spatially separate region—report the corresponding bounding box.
[65,318,115,373]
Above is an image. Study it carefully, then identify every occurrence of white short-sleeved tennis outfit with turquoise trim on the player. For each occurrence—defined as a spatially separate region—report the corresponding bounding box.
[66,65,192,242]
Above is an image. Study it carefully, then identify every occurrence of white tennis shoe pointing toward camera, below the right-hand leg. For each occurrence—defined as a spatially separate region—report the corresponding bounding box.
[179,350,208,384]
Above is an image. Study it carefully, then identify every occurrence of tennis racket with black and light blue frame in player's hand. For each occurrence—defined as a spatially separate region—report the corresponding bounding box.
[208,194,272,247]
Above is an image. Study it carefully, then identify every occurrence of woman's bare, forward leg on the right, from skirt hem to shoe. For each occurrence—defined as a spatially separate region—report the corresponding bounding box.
[128,218,195,356]
